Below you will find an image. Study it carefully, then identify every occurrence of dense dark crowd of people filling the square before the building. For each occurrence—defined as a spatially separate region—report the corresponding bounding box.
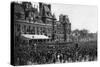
[14,35,97,65]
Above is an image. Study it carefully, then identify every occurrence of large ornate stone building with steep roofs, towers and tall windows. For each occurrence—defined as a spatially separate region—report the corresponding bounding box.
[14,2,71,41]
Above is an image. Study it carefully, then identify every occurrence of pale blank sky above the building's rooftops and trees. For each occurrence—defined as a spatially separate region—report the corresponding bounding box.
[33,3,98,33]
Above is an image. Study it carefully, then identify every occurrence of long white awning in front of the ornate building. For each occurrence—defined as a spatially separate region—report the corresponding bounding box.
[21,34,50,39]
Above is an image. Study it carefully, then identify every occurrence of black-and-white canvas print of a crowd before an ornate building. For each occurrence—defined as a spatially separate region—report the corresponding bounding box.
[10,1,98,66]
